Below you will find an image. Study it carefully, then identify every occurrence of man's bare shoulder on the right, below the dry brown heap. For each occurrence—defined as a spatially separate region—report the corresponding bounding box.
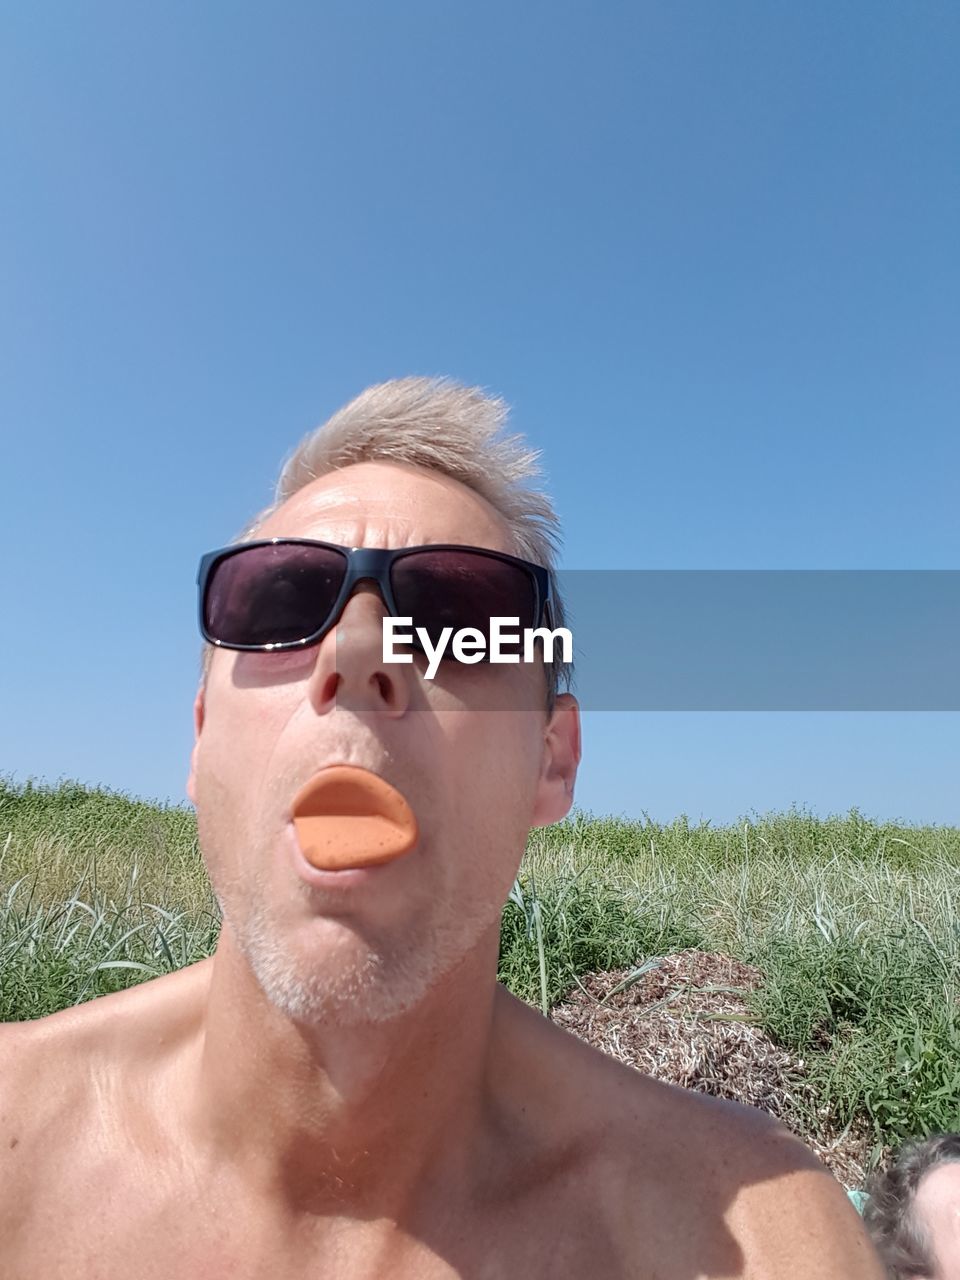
[499,993,883,1280]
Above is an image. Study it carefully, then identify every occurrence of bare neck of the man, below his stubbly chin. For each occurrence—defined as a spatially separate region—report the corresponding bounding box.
[183,927,508,1221]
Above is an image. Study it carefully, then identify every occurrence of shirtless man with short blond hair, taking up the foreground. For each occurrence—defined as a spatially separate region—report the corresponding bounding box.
[0,379,881,1280]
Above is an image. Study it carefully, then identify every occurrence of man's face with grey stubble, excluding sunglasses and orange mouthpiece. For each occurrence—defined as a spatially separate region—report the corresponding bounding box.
[188,462,579,1023]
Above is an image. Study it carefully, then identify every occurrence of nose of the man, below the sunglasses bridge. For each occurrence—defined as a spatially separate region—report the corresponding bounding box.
[310,582,413,717]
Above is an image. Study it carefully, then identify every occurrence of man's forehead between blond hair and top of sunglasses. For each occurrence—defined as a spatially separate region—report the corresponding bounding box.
[256,462,515,553]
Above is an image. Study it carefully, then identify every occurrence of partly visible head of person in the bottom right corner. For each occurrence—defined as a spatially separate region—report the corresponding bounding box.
[864,1133,960,1280]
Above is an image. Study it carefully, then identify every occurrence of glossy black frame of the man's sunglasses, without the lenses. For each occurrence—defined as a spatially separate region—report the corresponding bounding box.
[197,538,550,653]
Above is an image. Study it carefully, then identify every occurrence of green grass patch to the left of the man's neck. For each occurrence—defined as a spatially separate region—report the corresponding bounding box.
[0,778,220,1020]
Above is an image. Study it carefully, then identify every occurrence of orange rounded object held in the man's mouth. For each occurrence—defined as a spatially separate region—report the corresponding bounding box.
[293,764,419,872]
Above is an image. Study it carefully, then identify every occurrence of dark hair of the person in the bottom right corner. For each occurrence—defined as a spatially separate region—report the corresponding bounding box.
[863,1133,960,1280]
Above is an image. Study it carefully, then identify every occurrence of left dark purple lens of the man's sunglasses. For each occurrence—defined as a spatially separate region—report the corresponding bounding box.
[204,543,347,645]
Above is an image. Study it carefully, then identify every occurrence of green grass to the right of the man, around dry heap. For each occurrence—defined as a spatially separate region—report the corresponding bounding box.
[514,810,960,1148]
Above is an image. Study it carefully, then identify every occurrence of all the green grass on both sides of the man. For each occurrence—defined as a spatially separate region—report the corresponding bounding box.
[0,780,960,1147]
